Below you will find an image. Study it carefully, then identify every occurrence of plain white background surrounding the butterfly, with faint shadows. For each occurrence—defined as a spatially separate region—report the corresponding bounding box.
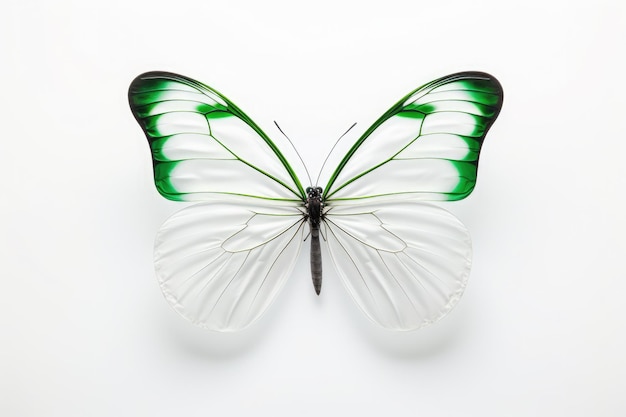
[0,0,626,417]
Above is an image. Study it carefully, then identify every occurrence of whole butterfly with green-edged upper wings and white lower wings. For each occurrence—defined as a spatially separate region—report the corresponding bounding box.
[128,72,503,331]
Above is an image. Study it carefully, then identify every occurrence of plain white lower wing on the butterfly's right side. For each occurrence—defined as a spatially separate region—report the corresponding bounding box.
[323,201,472,330]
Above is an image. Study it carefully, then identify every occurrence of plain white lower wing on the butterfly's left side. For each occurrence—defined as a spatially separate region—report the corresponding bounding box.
[154,202,304,331]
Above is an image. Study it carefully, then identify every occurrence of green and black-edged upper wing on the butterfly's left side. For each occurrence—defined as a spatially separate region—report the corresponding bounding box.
[128,72,305,201]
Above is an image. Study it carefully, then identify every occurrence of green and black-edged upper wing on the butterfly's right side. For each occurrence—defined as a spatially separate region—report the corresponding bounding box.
[324,72,503,203]
